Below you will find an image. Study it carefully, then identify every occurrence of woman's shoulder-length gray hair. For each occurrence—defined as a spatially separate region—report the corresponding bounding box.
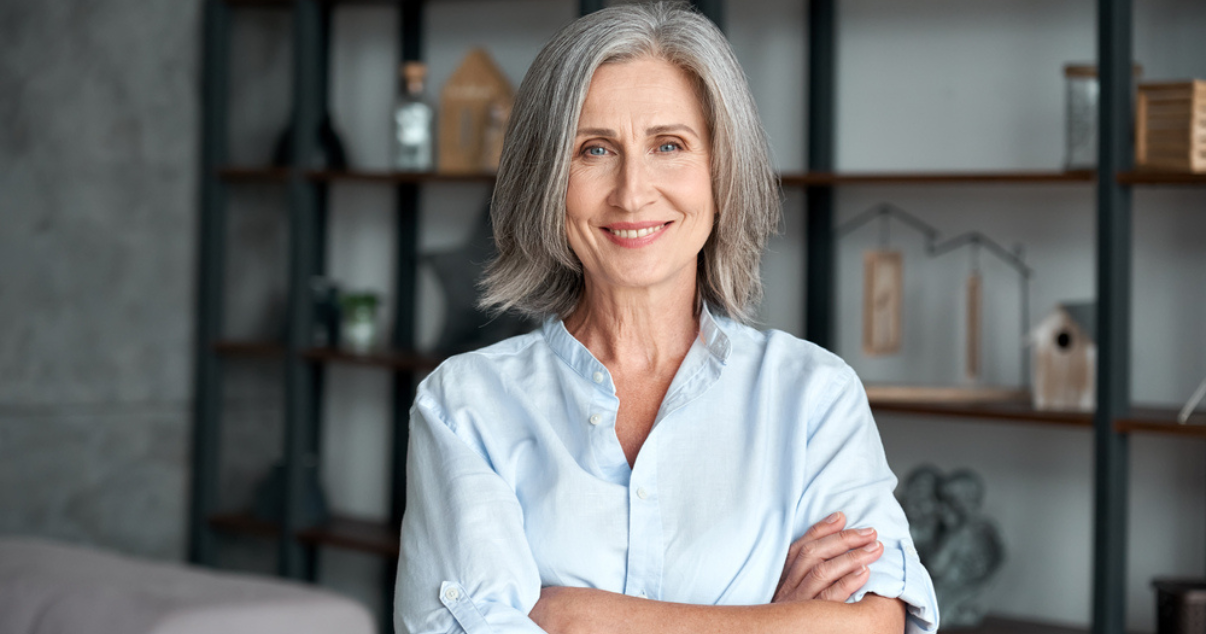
[480,2,780,322]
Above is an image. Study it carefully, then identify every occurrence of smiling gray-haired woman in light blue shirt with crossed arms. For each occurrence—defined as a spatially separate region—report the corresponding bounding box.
[394,5,937,634]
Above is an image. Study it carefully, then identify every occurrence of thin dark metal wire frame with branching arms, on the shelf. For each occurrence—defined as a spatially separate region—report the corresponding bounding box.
[833,202,1034,384]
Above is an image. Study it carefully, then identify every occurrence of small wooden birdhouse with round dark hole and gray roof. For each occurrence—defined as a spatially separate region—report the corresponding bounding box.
[1030,304,1097,411]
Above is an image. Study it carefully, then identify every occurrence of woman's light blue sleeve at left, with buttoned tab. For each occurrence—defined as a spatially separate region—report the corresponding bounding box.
[393,388,543,634]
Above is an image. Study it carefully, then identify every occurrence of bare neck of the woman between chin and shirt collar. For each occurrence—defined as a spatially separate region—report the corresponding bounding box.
[566,277,699,371]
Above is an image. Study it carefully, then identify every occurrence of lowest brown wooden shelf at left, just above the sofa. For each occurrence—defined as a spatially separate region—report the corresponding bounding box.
[209,511,398,557]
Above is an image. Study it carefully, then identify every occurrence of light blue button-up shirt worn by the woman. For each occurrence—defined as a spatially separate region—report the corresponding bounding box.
[394,310,938,634]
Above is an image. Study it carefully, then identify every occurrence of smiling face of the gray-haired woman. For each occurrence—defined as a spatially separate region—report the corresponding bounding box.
[566,59,715,298]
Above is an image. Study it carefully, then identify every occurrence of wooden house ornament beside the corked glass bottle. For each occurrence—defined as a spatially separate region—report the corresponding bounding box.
[438,48,515,174]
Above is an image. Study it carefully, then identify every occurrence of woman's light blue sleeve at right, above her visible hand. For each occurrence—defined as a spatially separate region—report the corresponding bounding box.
[797,368,938,634]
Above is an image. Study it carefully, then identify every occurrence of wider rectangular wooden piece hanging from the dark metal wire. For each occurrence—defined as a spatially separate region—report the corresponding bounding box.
[862,251,905,357]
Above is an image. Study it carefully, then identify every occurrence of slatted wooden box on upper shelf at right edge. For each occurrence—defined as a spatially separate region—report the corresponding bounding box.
[1135,80,1206,172]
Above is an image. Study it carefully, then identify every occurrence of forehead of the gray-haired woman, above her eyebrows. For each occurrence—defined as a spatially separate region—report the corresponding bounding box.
[581,58,704,127]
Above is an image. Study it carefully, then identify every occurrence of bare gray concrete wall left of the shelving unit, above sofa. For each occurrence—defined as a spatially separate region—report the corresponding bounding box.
[0,0,199,557]
